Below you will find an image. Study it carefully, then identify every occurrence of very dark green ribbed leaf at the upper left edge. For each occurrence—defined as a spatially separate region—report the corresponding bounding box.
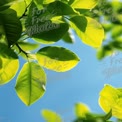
[0,9,22,45]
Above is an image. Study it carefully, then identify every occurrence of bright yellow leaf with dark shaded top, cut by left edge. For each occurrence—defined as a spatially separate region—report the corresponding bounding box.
[0,44,19,85]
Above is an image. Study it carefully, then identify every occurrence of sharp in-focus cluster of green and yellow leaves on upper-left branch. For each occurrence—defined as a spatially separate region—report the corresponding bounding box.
[0,0,104,106]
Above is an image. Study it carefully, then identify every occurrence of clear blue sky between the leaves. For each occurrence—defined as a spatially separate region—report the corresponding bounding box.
[0,34,122,122]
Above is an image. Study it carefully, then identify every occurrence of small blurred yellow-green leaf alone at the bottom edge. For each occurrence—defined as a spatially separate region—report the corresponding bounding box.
[41,109,63,122]
